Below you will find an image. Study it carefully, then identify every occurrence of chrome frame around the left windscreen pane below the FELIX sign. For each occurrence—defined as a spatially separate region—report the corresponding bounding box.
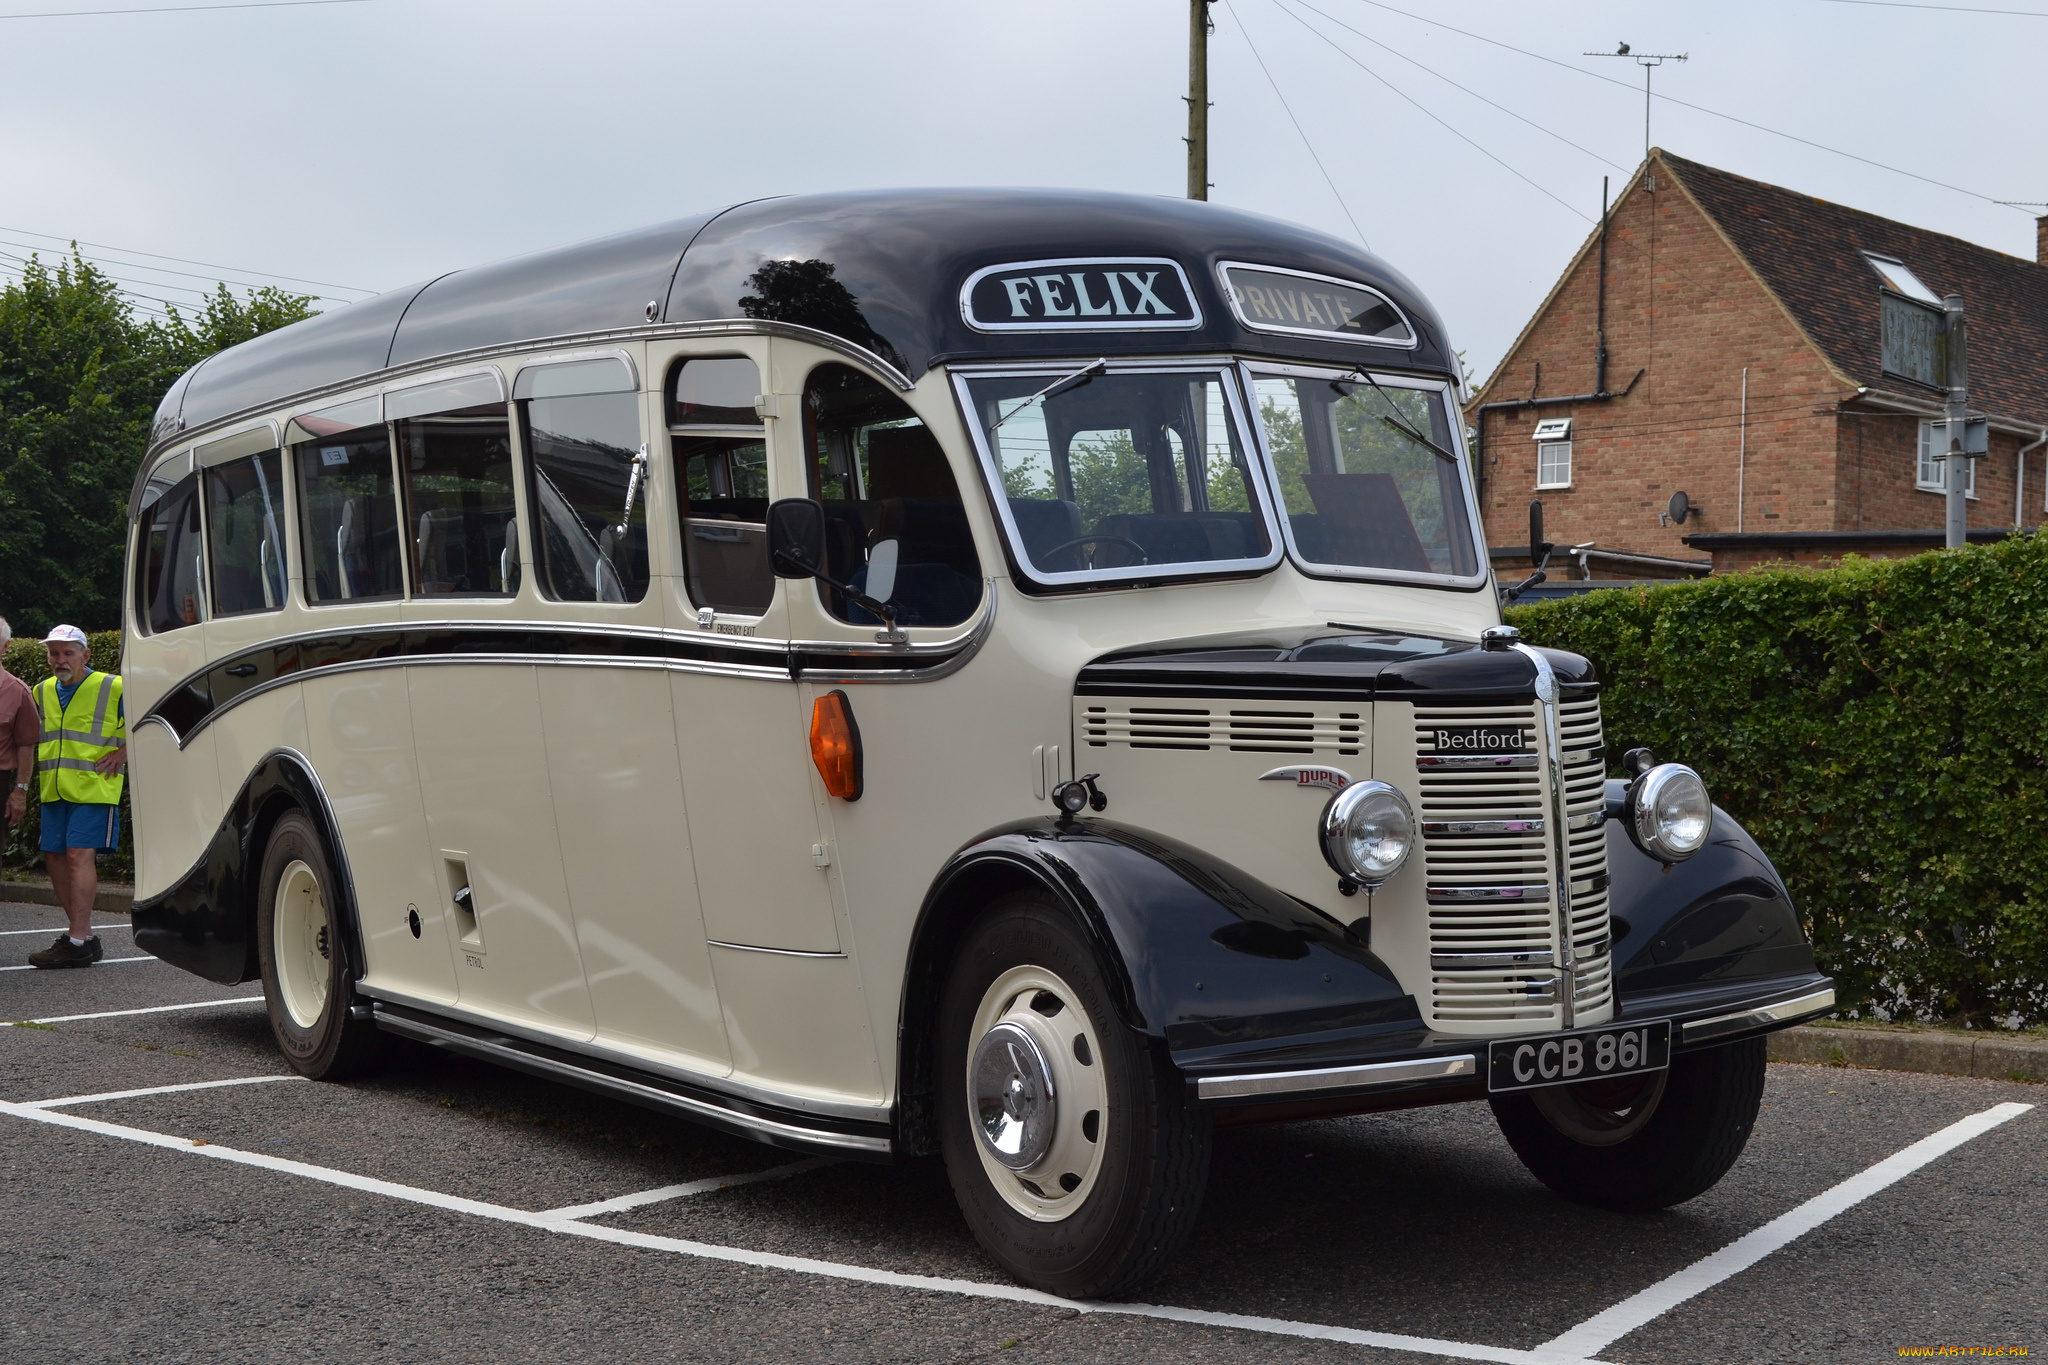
[946,356,1286,589]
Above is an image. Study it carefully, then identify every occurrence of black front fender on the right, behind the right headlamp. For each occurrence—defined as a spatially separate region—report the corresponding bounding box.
[1608,782,1817,1001]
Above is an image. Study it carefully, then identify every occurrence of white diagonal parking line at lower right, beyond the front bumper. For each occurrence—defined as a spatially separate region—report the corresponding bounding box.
[1536,1103,2034,1361]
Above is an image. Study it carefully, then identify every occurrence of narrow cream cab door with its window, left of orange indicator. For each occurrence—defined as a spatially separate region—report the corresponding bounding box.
[649,338,879,1097]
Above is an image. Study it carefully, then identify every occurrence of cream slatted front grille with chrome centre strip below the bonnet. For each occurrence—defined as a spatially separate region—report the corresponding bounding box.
[1415,702,1610,1027]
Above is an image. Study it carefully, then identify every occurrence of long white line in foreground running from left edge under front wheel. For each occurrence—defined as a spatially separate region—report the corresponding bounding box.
[0,1101,1565,1365]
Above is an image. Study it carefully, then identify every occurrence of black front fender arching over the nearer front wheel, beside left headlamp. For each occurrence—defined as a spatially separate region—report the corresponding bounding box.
[920,819,1419,1064]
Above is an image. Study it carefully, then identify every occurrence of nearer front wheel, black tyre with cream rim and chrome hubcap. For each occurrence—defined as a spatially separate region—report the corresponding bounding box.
[938,892,1210,1297]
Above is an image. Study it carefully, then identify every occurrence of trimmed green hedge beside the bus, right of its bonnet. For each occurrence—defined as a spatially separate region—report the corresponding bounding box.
[1507,538,2048,1027]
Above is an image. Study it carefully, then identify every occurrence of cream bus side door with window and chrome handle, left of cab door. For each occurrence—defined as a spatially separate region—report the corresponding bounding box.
[512,356,729,1074]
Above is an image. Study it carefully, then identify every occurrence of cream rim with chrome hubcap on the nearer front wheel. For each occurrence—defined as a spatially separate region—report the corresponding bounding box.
[967,966,1110,1224]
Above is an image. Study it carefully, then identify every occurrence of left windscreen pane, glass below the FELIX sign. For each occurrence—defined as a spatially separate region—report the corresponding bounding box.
[967,370,1272,575]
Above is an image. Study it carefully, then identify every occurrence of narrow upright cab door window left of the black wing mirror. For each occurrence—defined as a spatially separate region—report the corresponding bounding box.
[668,356,774,616]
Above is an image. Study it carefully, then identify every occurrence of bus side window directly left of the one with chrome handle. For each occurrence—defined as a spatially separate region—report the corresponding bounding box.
[395,403,518,598]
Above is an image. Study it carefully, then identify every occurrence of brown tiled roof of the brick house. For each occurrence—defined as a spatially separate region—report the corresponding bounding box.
[1659,151,2048,424]
